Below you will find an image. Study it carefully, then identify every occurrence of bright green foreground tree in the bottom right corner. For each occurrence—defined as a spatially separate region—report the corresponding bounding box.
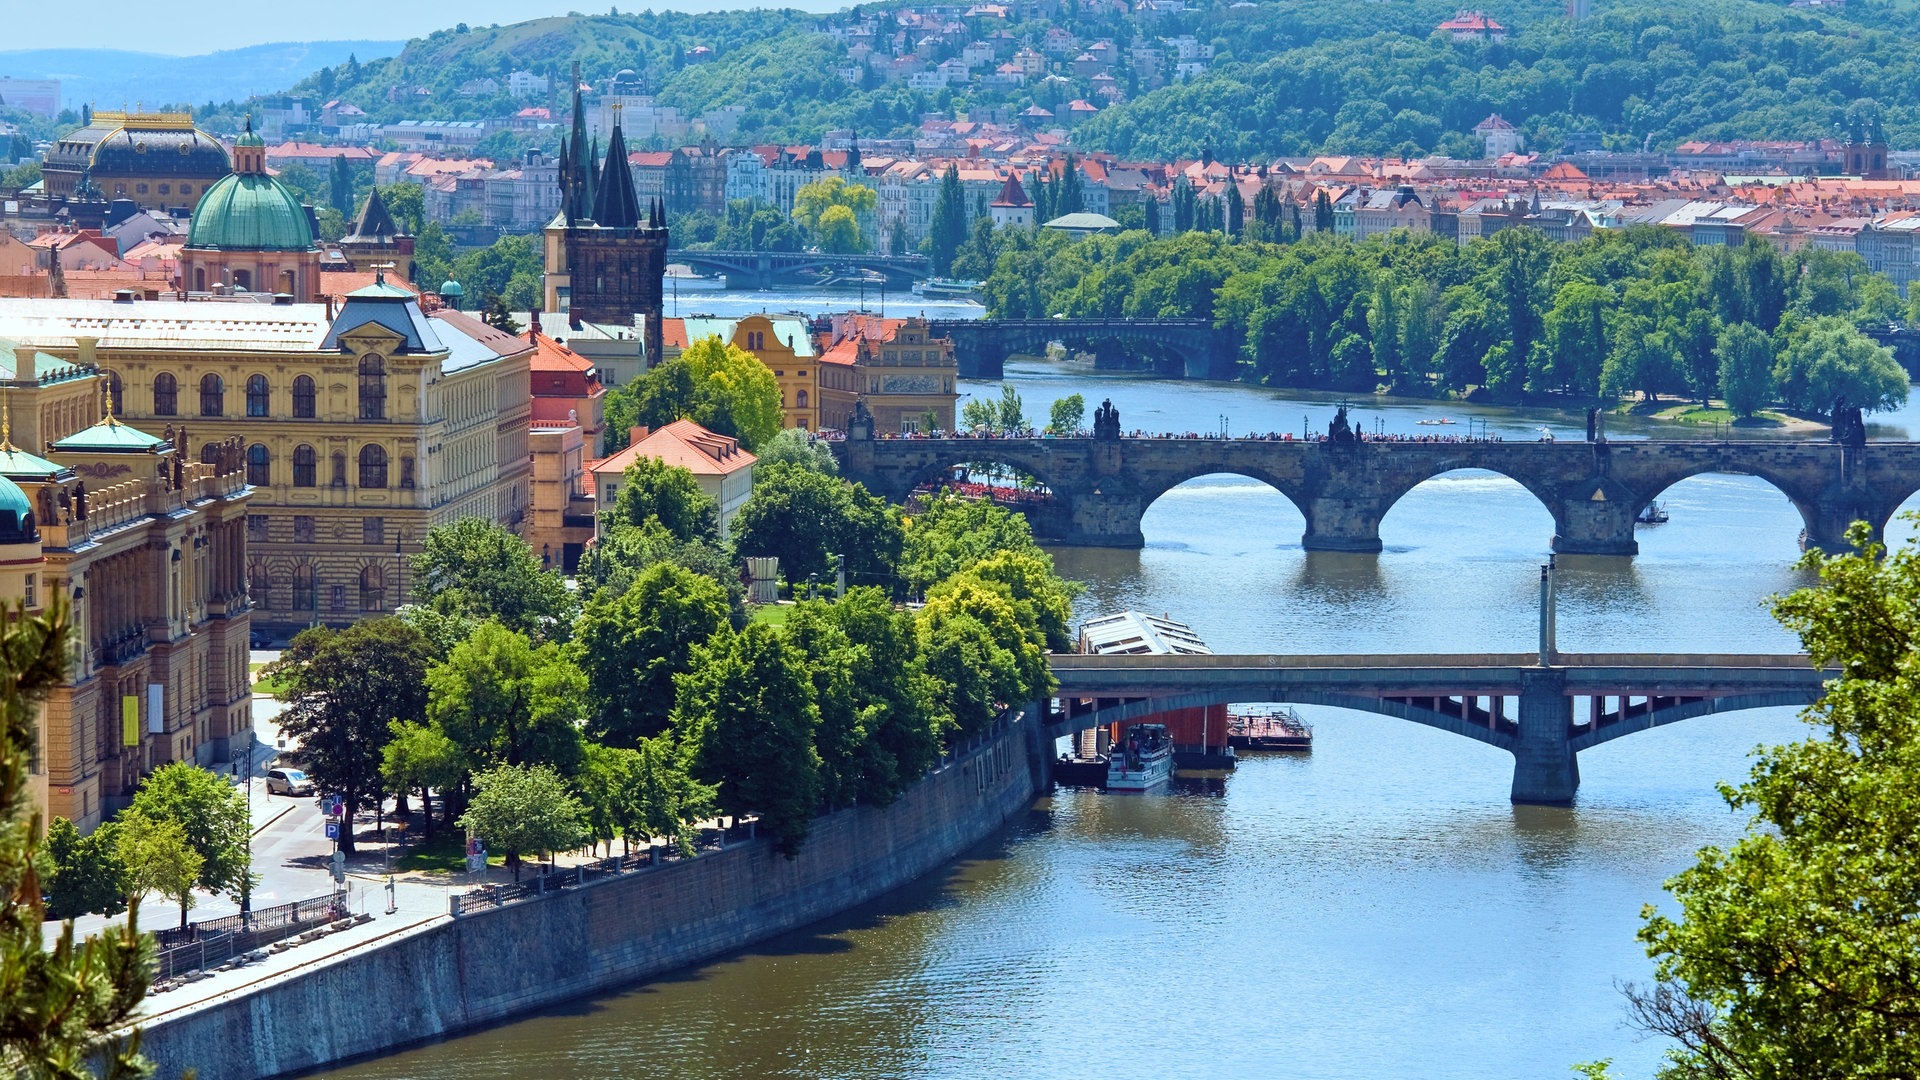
[1628,523,1920,1080]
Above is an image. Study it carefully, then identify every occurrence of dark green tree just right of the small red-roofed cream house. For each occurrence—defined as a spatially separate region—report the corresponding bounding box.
[733,455,904,586]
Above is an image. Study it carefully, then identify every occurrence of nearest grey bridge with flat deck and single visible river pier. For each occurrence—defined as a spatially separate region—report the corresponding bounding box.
[1048,653,1836,805]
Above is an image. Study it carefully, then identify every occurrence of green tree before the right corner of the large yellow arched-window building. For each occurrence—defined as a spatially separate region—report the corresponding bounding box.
[413,517,572,638]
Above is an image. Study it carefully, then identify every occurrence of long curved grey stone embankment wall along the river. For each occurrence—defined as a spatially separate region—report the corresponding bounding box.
[142,719,1046,1080]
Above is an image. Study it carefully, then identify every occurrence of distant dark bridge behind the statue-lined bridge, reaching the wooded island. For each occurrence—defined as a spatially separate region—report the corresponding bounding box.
[931,319,1235,379]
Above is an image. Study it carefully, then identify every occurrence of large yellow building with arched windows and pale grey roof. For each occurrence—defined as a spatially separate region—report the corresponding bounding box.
[0,282,532,636]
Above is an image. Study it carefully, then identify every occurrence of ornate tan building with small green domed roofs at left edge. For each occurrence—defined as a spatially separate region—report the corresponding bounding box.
[0,342,252,830]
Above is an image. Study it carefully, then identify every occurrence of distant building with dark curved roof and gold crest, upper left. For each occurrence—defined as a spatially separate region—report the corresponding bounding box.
[42,111,232,209]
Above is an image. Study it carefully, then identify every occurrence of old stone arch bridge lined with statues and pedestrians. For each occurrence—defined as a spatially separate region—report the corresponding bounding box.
[835,432,1920,555]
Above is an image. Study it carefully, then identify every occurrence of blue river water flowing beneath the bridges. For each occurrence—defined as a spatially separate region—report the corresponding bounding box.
[318,286,1920,1080]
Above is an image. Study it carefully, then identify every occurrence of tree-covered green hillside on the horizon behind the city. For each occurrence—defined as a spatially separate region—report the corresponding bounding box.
[214,0,1920,160]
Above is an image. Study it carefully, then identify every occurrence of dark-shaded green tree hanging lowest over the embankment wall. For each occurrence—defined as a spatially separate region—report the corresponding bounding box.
[674,625,820,857]
